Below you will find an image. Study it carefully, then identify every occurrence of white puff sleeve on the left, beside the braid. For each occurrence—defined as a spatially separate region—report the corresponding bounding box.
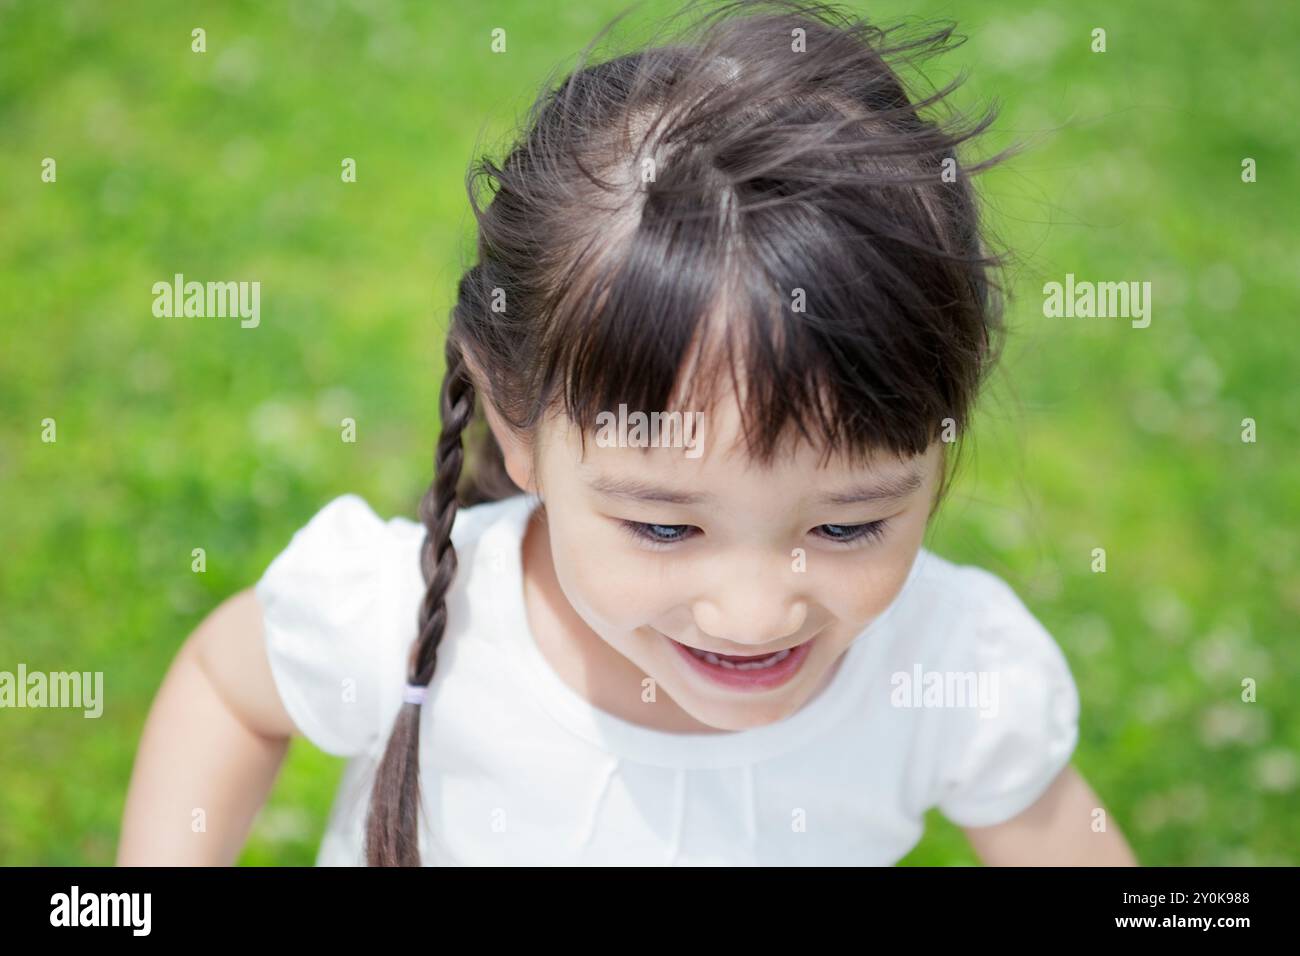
[255,494,420,757]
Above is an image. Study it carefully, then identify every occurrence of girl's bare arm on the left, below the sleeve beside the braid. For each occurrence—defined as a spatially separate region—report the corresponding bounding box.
[117,589,296,866]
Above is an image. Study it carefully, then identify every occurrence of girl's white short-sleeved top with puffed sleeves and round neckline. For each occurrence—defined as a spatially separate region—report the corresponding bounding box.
[256,494,1079,866]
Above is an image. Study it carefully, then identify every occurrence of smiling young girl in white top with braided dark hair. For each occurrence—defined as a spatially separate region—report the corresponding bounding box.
[120,3,1132,865]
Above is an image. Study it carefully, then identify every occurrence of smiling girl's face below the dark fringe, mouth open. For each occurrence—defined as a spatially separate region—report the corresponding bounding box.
[491,390,943,730]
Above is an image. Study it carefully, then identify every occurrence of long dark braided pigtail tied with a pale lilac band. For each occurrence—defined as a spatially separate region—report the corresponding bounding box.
[365,334,475,866]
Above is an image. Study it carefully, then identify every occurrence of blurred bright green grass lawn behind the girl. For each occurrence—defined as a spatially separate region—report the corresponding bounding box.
[0,0,1300,865]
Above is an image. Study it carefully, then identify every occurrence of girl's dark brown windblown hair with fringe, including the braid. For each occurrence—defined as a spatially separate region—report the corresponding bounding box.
[365,0,1005,866]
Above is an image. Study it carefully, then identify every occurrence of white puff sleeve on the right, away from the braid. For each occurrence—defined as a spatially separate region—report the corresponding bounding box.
[936,568,1079,827]
